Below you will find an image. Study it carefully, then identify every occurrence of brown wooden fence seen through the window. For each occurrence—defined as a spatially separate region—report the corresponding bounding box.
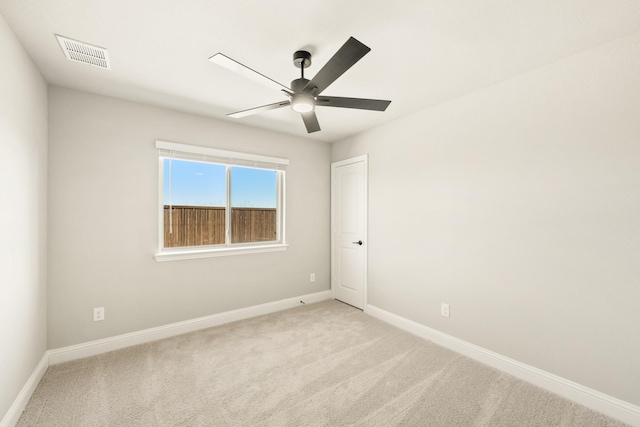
[164,205,276,248]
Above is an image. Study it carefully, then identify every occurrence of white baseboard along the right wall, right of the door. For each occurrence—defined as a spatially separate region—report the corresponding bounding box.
[364,305,640,426]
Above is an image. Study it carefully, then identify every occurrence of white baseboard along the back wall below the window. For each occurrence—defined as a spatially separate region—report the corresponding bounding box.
[48,291,331,365]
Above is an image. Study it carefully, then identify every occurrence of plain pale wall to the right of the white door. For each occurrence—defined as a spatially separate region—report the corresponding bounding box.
[332,33,640,405]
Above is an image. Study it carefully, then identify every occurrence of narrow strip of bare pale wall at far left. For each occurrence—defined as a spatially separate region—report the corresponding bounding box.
[0,16,47,417]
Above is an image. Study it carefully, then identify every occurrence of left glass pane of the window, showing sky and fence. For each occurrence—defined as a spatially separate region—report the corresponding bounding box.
[163,159,227,248]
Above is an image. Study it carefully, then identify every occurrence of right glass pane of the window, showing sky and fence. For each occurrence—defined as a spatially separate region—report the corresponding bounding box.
[231,166,277,243]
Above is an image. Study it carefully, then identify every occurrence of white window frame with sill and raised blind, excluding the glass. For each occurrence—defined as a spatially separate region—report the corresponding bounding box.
[154,140,289,262]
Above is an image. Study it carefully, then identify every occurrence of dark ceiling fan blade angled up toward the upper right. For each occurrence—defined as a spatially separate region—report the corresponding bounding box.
[303,37,371,95]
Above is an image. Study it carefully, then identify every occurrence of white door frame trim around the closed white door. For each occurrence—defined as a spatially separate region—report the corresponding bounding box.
[330,154,369,311]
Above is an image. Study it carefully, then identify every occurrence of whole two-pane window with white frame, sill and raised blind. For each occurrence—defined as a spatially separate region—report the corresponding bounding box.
[155,141,289,261]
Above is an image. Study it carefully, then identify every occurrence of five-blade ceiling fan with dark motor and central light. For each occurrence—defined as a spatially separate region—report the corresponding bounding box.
[209,37,391,133]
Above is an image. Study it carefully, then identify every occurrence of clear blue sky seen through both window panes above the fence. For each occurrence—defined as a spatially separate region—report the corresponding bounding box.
[164,159,276,208]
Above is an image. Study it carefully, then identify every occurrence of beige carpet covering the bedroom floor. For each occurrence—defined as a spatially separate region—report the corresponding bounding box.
[18,301,624,427]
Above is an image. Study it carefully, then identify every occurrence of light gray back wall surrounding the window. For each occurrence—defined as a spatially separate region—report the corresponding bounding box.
[49,87,330,348]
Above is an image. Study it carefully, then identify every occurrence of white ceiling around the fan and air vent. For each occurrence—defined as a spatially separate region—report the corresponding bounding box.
[0,0,640,141]
